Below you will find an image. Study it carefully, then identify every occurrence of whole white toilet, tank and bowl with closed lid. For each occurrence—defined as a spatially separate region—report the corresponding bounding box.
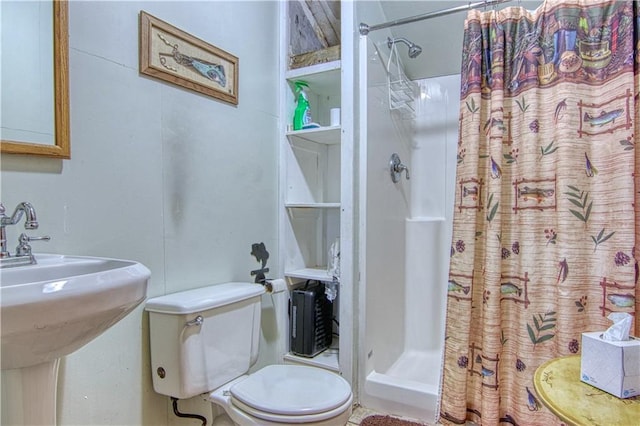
[145,282,353,426]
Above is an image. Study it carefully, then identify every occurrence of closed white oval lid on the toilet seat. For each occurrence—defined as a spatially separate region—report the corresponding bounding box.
[229,365,351,416]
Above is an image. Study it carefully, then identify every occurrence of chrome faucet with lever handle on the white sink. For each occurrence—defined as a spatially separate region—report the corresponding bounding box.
[0,201,50,267]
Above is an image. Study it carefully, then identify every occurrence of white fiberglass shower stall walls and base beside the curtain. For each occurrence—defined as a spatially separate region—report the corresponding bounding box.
[358,19,460,421]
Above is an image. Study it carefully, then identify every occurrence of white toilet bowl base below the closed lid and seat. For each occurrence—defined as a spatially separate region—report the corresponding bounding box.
[208,375,352,426]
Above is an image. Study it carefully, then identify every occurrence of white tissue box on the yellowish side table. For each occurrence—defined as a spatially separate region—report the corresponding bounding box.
[580,331,640,398]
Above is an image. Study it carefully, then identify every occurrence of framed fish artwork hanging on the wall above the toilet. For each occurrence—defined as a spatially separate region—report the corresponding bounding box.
[139,11,238,105]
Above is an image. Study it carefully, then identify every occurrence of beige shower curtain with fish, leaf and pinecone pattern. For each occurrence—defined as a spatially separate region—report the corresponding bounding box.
[440,0,640,425]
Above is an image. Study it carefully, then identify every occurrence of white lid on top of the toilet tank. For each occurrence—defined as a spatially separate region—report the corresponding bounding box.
[145,282,265,314]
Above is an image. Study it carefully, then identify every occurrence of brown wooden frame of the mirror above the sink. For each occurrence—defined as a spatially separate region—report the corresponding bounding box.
[0,0,71,159]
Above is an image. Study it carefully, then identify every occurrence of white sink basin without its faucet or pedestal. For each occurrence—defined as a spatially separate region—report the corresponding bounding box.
[0,254,151,369]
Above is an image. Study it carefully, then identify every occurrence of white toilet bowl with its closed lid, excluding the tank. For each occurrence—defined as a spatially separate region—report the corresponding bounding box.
[209,365,353,426]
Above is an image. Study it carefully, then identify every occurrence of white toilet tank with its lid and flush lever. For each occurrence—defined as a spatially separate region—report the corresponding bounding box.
[145,282,265,399]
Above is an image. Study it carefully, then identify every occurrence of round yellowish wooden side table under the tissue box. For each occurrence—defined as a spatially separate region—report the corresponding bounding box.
[533,355,640,426]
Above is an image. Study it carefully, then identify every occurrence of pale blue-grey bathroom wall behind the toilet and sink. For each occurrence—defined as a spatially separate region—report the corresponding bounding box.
[1,1,279,425]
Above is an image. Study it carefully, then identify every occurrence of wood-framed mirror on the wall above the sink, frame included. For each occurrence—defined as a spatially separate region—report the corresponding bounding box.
[0,0,71,158]
